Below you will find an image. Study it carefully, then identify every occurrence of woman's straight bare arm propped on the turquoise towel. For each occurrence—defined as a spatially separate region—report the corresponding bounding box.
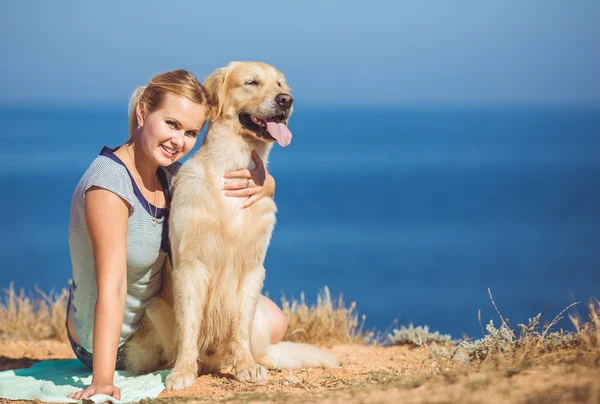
[70,187,129,400]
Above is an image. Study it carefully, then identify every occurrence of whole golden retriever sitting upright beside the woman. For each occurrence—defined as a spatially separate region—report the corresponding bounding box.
[126,62,338,390]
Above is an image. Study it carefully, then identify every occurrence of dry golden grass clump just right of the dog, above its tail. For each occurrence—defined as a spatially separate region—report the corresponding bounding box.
[281,286,372,345]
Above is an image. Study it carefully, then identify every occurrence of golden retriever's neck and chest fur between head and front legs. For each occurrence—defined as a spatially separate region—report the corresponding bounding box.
[169,130,276,352]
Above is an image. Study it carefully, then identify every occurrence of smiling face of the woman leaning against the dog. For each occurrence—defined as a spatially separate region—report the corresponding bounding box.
[137,93,207,166]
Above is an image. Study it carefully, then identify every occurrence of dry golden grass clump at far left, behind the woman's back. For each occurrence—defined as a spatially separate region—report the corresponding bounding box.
[0,282,69,341]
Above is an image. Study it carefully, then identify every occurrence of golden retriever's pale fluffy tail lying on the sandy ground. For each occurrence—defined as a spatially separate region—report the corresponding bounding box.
[259,342,340,369]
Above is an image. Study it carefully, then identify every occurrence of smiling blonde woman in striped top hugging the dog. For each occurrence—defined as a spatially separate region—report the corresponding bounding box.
[67,70,287,400]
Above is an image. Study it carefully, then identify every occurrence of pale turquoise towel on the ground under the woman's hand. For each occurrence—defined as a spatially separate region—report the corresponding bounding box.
[0,359,169,403]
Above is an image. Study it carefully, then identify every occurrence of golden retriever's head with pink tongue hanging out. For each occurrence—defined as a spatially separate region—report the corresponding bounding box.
[204,62,294,147]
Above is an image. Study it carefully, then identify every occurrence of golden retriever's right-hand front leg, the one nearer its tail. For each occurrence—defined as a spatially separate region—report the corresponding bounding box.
[231,266,268,382]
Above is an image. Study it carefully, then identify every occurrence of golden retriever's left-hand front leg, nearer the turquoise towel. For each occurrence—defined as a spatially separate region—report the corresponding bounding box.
[165,260,208,390]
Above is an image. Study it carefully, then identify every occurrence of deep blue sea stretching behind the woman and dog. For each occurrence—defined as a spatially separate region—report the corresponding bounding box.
[0,106,600,337]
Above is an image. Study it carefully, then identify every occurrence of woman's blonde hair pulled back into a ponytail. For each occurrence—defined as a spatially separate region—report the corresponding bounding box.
[129,70,209,139]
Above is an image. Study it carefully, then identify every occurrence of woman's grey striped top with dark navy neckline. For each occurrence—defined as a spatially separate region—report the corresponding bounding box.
[69,146,181,352]
